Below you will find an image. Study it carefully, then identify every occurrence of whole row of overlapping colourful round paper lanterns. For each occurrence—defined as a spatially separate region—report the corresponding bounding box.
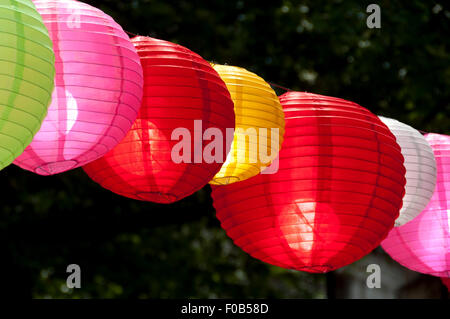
[0,0,450,282]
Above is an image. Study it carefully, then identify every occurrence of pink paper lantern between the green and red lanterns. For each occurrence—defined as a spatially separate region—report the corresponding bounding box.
[15,0,143,175]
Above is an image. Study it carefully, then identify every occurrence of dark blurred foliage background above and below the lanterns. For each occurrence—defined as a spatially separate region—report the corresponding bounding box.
[0,0,450,298]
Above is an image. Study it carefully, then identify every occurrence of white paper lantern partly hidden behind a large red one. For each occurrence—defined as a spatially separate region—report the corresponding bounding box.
[380,116,436,226]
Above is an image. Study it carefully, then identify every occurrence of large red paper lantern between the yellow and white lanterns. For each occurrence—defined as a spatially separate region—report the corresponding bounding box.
[212,92,405,273]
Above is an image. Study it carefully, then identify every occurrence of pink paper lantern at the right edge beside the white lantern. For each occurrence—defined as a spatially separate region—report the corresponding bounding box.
[382,134,450,277]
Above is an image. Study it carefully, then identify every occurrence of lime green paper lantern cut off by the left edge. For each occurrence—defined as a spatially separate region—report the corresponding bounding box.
[0,0,55,169]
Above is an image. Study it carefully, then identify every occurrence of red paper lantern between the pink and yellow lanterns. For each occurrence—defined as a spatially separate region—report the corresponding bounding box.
[84,37,234,203]
